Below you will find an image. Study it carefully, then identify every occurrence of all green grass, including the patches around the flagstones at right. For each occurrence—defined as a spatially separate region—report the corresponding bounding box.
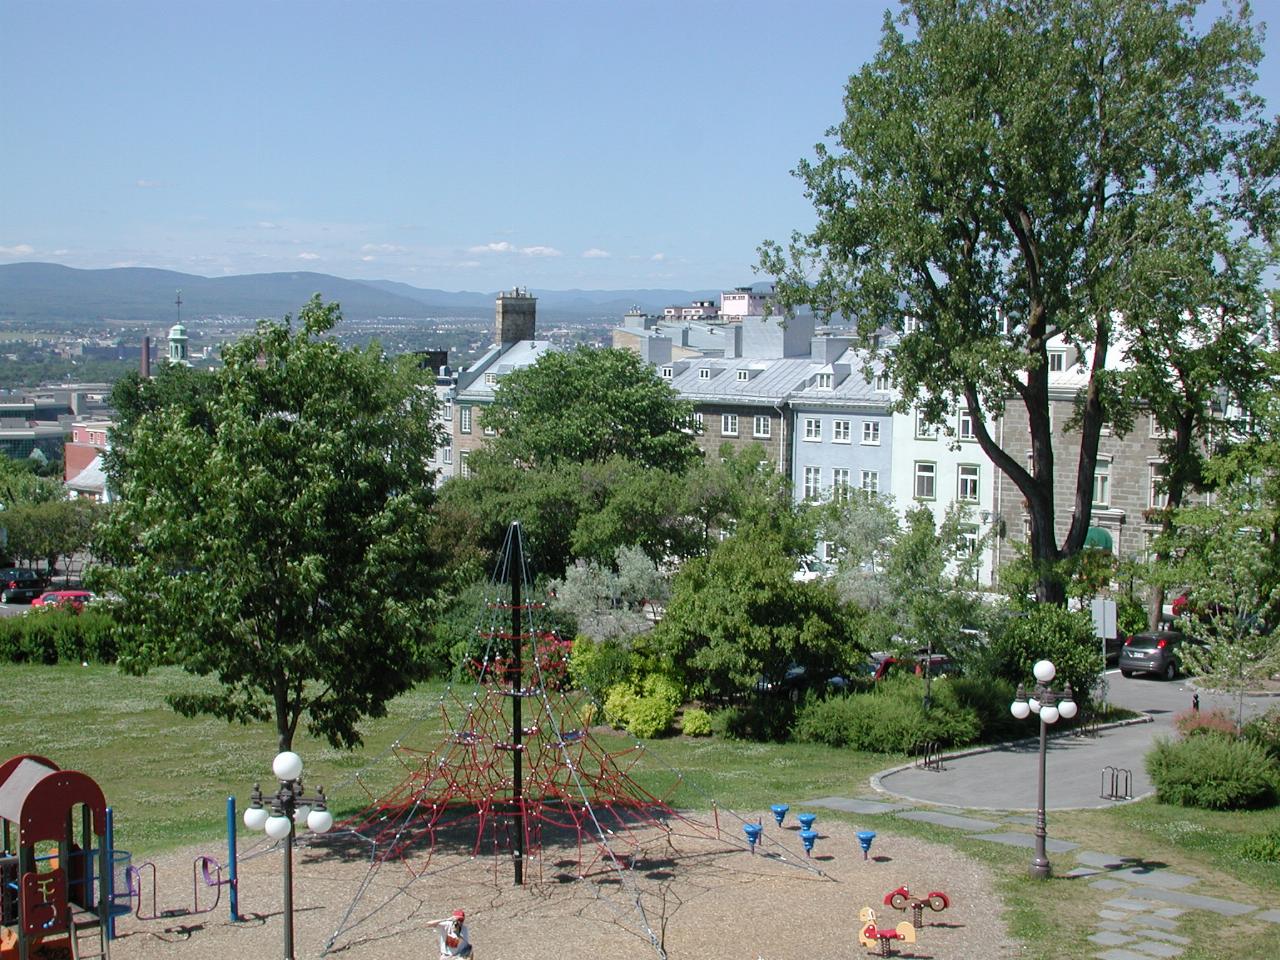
[0,664,1280,960]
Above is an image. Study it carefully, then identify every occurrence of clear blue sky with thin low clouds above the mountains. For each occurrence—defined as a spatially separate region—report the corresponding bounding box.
[0,0,1280,291]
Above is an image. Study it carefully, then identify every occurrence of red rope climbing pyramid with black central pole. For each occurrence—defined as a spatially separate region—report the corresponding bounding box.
[305,524,823,957]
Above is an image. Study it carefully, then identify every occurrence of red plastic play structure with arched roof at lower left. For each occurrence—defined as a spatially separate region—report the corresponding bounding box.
[0,754,113,960]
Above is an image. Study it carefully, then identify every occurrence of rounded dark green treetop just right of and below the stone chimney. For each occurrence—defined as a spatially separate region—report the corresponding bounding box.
[480,347,700,474]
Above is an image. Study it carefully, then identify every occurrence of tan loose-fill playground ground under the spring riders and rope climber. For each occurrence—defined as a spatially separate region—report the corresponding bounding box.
[102,808,1016,960]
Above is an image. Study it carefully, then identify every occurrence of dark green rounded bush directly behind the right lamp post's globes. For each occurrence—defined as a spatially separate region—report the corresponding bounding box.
[982,603,1102,704]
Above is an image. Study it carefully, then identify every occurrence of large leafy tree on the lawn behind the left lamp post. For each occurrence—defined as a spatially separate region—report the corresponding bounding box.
[95,297,439,750]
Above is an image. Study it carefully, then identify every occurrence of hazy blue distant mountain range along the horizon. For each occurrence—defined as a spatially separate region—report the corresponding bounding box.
[0,262,742,324]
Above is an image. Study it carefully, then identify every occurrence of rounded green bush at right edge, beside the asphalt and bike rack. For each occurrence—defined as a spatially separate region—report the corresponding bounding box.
[1146,736,1276,810]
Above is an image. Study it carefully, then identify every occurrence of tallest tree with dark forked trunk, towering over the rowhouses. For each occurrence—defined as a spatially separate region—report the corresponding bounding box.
[762,0,1280,603]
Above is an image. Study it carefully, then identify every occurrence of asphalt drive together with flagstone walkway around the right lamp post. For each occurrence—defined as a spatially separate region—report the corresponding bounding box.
[804,675,1280,960]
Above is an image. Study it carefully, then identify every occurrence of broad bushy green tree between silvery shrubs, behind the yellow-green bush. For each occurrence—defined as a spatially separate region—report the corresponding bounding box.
[653,534,864,700]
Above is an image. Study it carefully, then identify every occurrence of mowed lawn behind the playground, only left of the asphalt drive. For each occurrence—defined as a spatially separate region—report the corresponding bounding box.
[0,664,895,854]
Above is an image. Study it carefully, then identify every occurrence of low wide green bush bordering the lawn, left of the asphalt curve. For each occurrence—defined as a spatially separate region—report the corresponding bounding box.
[794,677,980,753]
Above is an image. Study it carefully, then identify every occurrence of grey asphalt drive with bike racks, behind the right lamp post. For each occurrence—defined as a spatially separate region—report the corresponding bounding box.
[879,671,1280,810]
